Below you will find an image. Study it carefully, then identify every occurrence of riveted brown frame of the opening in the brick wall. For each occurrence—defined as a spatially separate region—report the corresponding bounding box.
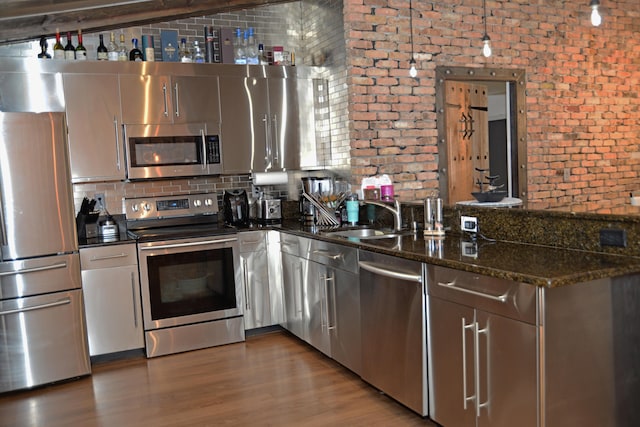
[436,66,528,207]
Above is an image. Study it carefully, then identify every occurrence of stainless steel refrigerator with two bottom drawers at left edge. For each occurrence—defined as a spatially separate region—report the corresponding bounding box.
[0,113,91,393]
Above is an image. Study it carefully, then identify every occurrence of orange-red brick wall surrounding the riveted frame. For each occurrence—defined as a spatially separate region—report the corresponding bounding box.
[344,0,640,212]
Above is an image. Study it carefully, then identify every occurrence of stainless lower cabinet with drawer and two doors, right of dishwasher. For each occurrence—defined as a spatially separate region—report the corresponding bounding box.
[428,266,538,427]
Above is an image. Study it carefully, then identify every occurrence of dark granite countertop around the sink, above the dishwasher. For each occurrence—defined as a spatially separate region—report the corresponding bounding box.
[280,221,640,288]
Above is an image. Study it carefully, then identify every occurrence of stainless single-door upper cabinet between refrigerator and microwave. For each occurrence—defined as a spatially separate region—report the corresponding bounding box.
[63,74,125,182]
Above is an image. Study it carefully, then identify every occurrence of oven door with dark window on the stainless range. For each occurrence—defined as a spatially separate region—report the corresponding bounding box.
[138,235,244,331]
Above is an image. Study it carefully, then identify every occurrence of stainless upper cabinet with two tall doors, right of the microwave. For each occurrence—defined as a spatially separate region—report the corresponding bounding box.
[220,76,300,173]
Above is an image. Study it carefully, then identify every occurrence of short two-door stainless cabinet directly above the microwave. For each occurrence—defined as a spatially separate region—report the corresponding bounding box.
[120,74,220,124]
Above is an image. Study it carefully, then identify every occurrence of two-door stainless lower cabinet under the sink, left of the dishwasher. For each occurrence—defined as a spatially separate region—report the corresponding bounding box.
[281,234,362,373]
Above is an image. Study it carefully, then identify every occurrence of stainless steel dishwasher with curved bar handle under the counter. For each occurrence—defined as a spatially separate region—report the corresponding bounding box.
[358,250,428,416]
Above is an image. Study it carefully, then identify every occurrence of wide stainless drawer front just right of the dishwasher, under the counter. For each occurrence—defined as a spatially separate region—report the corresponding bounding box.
[427,265,538,324]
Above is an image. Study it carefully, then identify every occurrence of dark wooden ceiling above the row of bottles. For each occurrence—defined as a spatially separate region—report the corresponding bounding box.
[0,0,293,44]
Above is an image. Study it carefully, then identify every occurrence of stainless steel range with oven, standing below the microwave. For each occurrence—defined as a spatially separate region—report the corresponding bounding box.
[123,194,244,357]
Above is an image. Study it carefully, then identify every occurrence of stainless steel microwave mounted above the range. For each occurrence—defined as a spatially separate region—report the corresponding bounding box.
[124,123,222,180]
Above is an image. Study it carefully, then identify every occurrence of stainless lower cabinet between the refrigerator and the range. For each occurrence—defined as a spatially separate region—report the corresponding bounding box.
[80,244,144,356]
